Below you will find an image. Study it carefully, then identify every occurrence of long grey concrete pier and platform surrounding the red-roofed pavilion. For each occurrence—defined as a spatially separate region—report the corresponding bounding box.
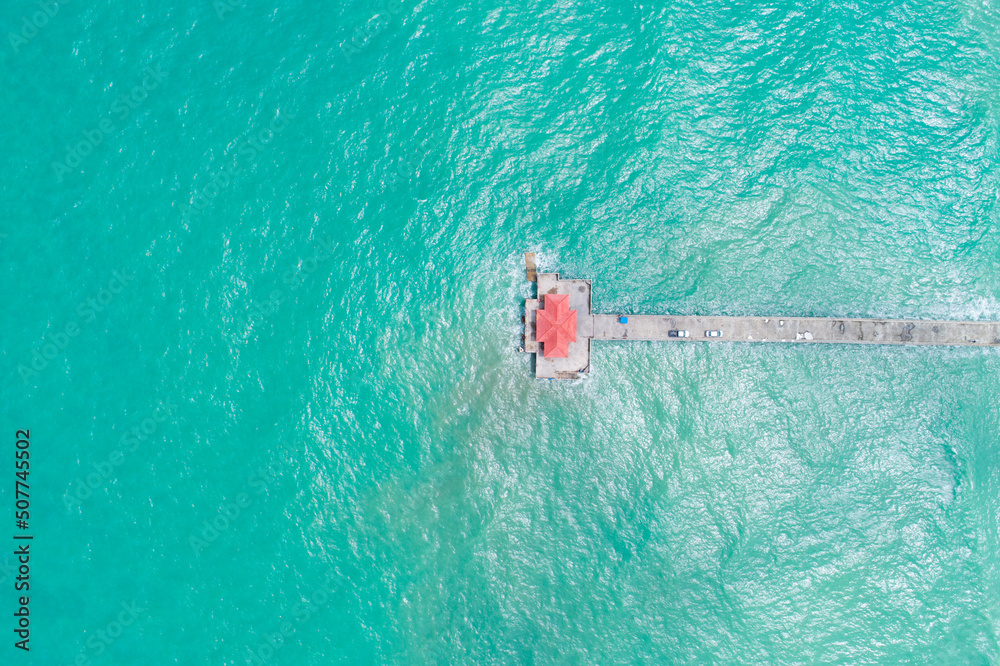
[523,264,1000,379]
